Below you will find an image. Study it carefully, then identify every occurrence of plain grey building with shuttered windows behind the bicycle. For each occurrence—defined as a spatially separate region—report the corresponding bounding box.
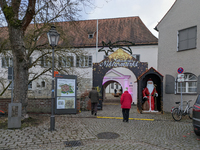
[155,0,200,112]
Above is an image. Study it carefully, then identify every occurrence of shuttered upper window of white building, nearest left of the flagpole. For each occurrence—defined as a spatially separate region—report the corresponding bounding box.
[76,56,92,67]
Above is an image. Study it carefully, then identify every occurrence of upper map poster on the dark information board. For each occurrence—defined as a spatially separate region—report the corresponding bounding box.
[57,78,76,96]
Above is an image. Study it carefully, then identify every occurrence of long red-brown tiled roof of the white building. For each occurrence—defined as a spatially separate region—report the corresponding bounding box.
[0,17,158,47]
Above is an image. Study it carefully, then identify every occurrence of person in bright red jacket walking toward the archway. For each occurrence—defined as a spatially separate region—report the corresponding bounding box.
[120,89,132,122]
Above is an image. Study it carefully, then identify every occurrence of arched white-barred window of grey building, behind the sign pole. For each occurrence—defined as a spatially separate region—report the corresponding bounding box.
[177,73,197,93]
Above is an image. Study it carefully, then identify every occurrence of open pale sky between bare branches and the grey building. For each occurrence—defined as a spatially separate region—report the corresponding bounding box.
[79,0,176,37]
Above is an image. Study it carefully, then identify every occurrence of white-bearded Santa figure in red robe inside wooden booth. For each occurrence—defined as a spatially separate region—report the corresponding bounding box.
[142,79,158,111]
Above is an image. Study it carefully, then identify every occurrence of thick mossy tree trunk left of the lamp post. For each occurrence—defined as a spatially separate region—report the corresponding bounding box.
[9,26,29,116]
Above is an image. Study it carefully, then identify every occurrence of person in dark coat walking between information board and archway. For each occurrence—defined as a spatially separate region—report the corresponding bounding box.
[88,87,99,116]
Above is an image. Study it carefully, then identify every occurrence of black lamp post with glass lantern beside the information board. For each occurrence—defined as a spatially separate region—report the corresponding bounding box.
[47,26,60,131]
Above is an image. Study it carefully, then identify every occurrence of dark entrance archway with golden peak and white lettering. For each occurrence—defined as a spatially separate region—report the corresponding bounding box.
[93,49,148,109]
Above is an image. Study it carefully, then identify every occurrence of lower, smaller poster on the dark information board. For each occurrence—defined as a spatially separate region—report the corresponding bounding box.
[57,97,75,109]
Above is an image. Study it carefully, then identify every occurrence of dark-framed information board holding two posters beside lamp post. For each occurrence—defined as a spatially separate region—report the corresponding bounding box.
[55,74,77,114]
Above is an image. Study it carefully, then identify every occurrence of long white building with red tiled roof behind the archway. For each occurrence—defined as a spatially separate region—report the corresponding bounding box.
[0,17,158,105]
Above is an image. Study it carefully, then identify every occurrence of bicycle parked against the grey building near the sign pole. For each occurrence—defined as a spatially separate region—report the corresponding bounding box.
[171,100,193,121]
